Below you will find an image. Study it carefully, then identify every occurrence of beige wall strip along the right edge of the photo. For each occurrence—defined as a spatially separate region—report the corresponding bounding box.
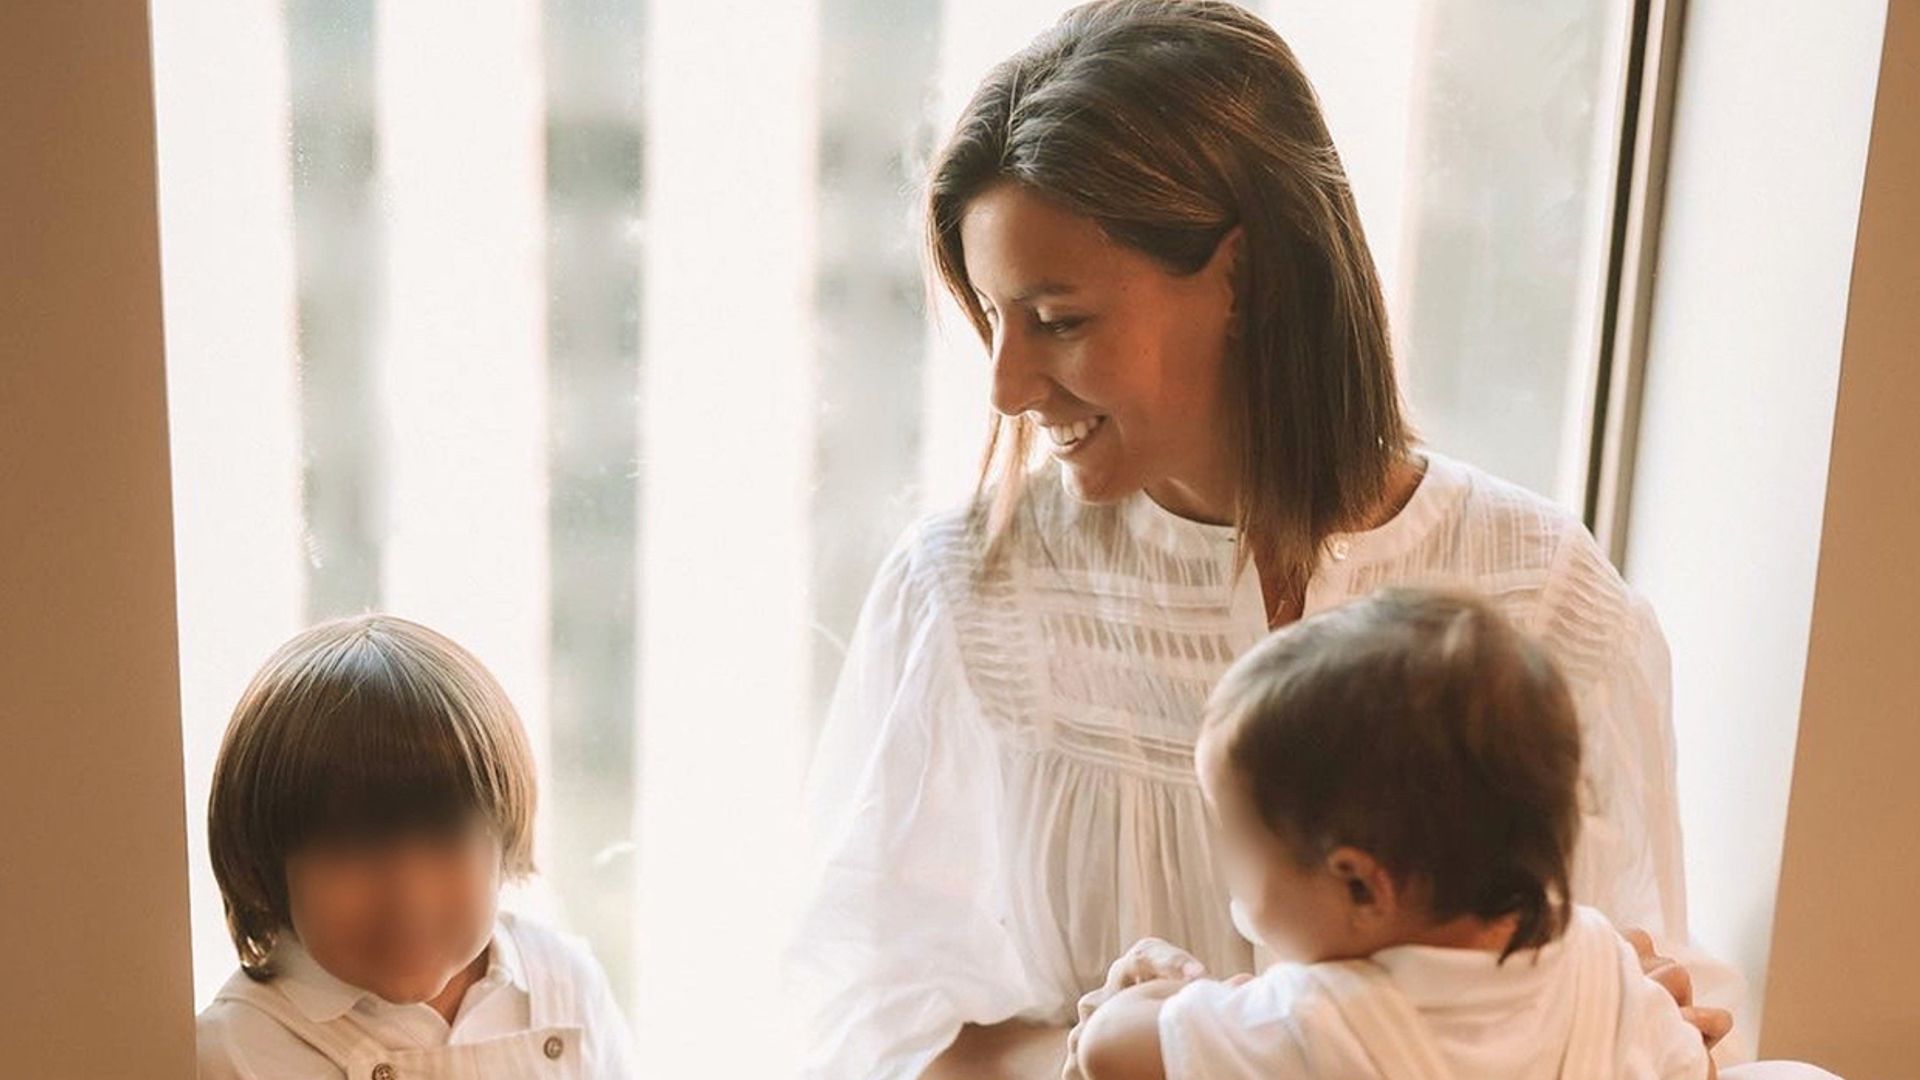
[1761,0,1920,1080]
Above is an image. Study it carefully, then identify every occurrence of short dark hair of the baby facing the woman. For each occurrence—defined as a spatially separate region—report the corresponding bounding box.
[1206,588,1580,959]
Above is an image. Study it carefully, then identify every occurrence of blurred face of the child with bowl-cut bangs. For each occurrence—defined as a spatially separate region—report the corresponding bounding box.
[286,824,501,1003]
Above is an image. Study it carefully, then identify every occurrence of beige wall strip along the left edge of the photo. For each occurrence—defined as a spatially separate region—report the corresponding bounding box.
[0,0,194,1080]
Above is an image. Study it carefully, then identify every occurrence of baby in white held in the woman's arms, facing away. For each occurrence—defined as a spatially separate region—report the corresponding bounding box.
[1069,590,1713,1080]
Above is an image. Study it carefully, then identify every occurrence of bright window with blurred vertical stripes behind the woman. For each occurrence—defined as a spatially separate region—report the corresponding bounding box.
[154,0,1630,1076]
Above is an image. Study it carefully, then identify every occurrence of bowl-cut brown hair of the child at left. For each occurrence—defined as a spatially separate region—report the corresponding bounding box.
[207,615,536,980]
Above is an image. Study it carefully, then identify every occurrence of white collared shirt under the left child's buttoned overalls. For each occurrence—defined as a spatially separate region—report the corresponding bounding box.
[198,913,634,1080]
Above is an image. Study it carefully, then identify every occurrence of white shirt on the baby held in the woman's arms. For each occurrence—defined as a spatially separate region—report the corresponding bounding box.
[1160,909,1707,1080]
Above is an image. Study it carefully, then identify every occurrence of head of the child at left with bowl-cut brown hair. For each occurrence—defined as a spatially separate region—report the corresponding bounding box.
[207,615,534,1003]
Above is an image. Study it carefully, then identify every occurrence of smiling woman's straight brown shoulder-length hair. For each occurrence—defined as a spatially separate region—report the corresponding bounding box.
[927,0,1411,590]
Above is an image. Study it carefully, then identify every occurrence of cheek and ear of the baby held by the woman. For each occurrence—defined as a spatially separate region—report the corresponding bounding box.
[1194,728,1404,963]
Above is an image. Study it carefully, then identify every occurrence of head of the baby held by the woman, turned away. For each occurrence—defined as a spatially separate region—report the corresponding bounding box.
[1196,588,1580,963]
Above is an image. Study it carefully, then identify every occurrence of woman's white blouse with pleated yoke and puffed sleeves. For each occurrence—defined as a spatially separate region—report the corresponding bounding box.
[789,452,1718,1080]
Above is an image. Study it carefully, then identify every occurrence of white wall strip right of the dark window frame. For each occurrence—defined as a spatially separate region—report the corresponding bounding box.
[1626,0,1885,1045]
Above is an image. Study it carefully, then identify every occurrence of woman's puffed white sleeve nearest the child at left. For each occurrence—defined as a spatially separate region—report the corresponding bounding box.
[785,518,1039,1080]
